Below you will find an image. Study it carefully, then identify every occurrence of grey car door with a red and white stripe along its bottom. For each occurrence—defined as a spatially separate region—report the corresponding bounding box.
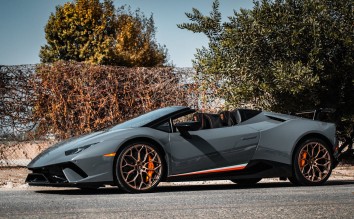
[170,125,259,176]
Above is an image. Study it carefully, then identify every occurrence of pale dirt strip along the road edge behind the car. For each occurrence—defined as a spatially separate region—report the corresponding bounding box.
[0,165,354,189]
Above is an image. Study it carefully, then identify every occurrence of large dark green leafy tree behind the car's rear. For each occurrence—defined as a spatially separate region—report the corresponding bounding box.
[178,0,354,119]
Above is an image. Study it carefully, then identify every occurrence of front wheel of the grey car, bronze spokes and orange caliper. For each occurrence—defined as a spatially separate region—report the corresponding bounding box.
[115,142,164,192]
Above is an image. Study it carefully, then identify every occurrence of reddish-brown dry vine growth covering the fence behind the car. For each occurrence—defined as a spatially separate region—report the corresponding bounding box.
[33,62,191,138]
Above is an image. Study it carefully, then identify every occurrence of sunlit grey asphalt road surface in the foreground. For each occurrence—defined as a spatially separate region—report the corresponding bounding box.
[0,181,354,218]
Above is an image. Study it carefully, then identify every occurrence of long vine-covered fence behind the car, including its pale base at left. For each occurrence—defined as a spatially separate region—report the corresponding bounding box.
[0,62,222,166]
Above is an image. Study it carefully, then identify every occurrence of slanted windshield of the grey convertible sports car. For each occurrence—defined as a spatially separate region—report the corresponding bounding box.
[111,107,185,130]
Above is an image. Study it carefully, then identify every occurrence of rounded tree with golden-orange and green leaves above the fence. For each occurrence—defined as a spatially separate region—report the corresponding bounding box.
[40,0,167,67]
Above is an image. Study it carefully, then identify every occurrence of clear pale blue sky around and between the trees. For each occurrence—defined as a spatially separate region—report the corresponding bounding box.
[0,0,253,67]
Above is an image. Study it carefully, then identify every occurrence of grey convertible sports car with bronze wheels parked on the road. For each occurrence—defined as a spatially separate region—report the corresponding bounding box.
[26,106,337,192]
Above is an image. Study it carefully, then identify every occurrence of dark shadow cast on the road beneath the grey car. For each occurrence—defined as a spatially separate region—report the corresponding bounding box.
[35,180,354,195]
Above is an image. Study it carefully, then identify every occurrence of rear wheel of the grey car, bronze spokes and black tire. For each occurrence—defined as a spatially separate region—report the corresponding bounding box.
[289,138,334,186]
